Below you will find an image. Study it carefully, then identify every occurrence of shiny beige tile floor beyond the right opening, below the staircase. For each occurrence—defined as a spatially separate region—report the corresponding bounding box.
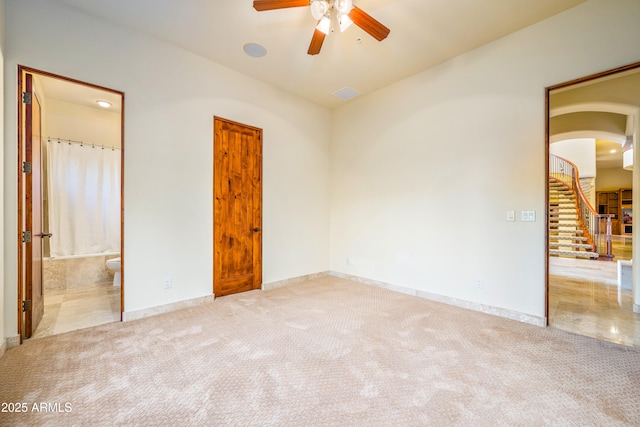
[549,238,640,347]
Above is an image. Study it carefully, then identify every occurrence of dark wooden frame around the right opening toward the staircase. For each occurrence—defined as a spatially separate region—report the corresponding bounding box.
[544,62,640,326]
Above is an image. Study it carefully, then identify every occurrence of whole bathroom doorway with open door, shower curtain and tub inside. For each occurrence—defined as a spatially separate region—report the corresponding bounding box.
[18,66,124,339]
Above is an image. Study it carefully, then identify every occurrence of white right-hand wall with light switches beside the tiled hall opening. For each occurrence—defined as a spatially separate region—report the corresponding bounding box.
[331,0,640,316]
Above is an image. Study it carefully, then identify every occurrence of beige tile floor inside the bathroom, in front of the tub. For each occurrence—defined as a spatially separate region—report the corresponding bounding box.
[31,282,120,339]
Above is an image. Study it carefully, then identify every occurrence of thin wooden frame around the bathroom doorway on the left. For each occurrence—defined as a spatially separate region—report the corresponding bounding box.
[16,65,124,344]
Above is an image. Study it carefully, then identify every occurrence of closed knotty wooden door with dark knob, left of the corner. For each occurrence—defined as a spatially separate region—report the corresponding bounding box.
[213,117,262,296]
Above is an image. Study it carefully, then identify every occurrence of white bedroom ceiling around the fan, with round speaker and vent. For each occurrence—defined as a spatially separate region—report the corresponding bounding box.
[58,0,585,108]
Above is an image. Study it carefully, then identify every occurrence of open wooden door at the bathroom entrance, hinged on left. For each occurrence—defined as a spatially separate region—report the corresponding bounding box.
[19,73,44,338]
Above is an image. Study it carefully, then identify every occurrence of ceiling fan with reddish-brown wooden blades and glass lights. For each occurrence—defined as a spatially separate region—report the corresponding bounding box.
[253,0,391,55]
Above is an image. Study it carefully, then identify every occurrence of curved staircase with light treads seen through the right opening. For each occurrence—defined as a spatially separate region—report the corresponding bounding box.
[549,177,599,259]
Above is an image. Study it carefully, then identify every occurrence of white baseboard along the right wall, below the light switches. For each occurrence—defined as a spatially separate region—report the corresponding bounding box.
[329,271,547,327]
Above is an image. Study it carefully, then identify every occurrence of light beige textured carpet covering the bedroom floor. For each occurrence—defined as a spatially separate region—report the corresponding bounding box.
[0,277,640,426]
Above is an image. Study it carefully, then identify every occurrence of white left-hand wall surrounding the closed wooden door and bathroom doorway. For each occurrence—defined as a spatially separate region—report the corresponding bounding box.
[4,0,331,335]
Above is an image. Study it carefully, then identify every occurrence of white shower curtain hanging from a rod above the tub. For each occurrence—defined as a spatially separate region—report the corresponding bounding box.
[47,141,120,257]
